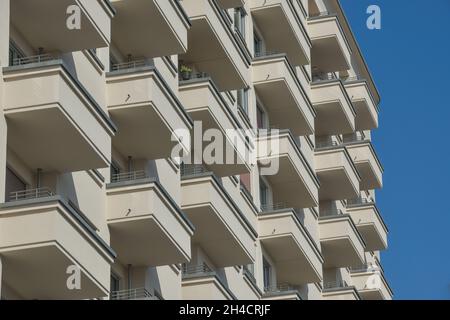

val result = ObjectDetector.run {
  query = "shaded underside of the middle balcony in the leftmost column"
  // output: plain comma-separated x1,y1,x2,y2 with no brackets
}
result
5,104,109,173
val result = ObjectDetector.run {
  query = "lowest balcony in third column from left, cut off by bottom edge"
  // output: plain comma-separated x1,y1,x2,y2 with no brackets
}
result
181,264,236,300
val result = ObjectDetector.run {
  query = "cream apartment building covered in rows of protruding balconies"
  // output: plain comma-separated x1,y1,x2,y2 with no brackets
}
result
0,0,392,300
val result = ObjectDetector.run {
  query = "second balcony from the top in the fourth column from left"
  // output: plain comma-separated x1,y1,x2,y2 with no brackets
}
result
252,54,315,136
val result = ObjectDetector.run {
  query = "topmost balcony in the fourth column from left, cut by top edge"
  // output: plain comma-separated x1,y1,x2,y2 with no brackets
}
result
250,0,312,66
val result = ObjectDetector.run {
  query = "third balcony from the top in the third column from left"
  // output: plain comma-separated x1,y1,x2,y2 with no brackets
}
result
181,167,257,268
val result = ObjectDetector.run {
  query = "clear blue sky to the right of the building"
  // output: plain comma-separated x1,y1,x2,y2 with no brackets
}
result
341,0,450,299
